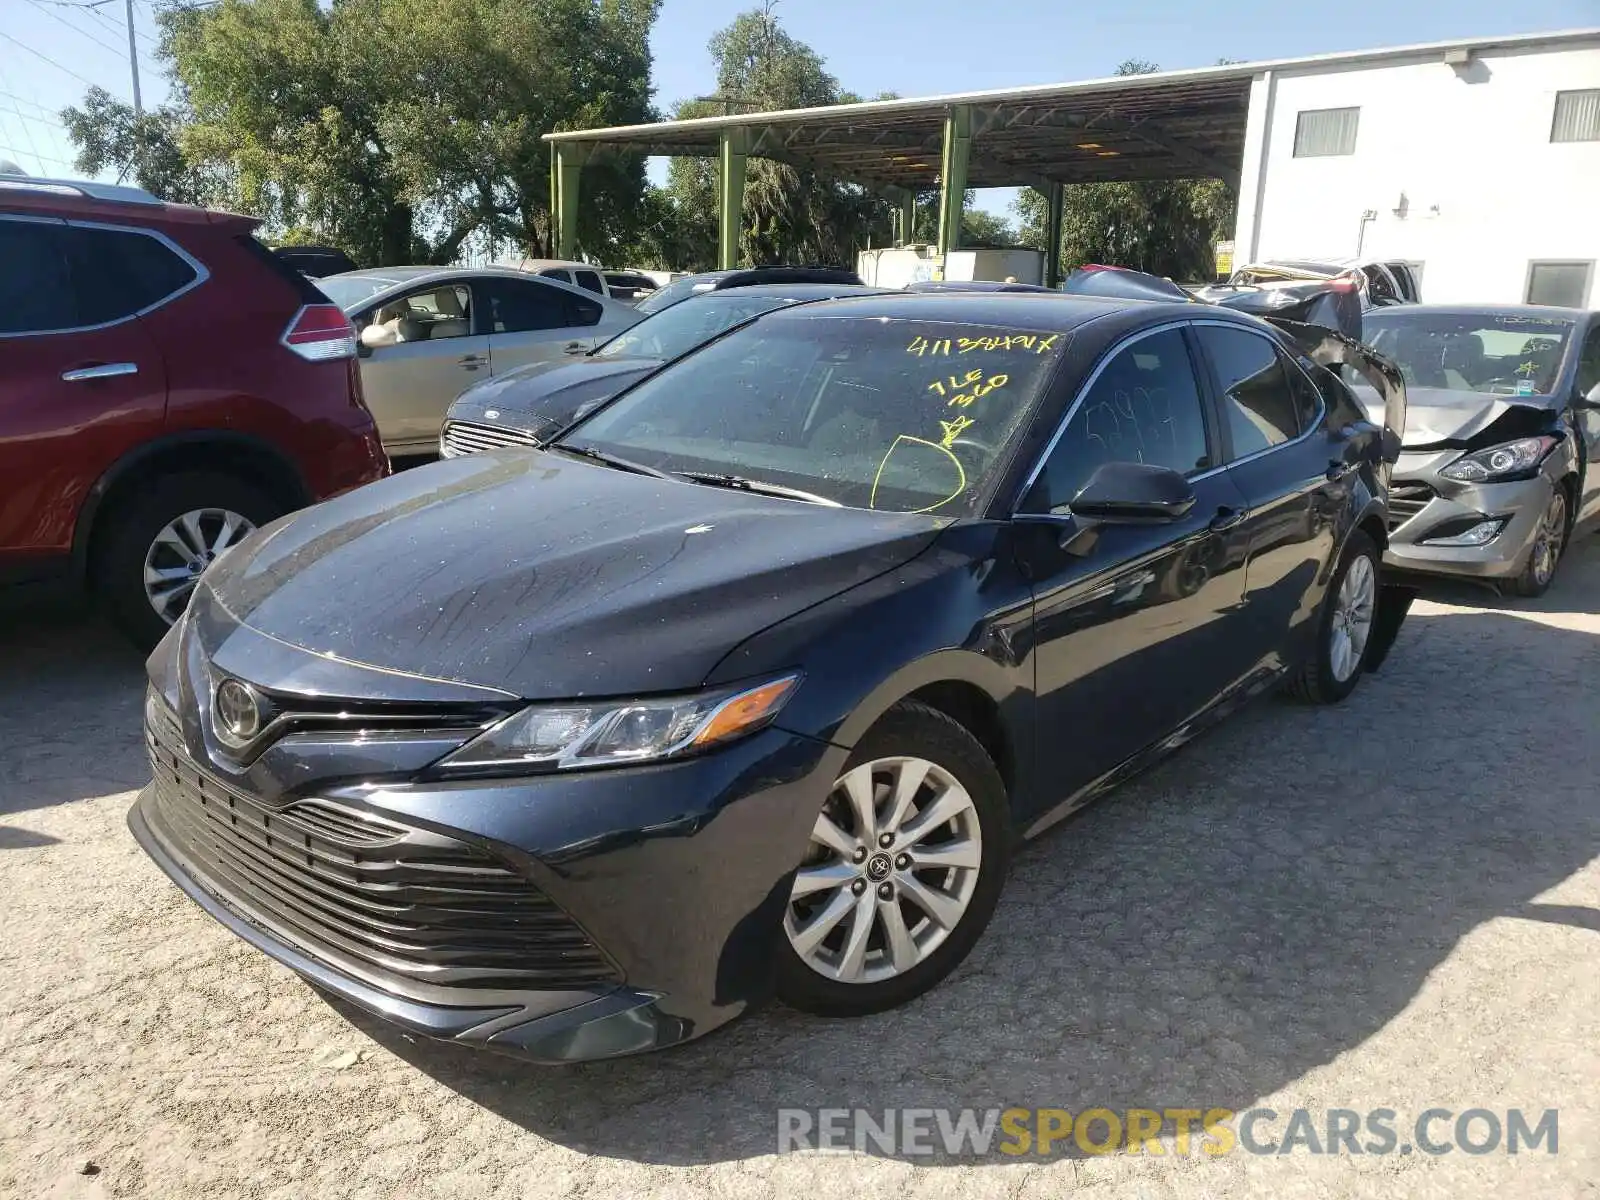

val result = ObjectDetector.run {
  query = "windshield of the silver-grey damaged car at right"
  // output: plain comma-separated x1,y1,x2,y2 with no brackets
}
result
1365,309,1573,395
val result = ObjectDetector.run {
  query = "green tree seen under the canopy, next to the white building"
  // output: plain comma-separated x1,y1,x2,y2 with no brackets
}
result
1014,59,1234,280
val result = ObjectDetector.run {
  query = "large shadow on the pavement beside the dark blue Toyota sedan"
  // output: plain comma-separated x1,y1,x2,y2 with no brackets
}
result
331,550,1600,1165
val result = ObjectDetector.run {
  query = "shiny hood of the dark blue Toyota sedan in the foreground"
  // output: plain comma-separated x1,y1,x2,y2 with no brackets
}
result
195,450,947,699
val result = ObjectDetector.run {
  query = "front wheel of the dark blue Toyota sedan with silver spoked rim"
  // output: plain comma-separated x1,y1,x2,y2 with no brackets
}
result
776,701,1011,1016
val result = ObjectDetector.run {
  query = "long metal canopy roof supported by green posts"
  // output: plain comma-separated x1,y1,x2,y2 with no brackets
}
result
546,29,1600,187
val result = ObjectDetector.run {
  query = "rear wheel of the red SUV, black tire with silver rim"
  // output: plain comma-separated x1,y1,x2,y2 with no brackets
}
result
90,472,283,653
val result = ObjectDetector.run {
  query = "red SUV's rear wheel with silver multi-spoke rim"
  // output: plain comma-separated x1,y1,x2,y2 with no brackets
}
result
90,474,283,650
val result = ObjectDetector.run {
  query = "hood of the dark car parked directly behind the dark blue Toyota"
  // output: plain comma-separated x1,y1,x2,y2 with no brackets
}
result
445,355,661,442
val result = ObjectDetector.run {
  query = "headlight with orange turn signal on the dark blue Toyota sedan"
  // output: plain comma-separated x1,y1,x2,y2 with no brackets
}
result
438,675,800,770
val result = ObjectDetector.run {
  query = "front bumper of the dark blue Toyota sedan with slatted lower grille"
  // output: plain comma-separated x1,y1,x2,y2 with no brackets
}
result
128,681,845,1062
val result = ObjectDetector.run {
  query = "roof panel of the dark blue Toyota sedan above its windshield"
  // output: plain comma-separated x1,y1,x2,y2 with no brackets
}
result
768,291,1211,331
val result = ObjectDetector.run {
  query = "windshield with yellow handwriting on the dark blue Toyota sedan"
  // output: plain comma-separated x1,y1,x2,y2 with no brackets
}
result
562,307,1067,517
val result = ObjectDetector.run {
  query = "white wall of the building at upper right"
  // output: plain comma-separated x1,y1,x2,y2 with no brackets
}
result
1235,37,1600,307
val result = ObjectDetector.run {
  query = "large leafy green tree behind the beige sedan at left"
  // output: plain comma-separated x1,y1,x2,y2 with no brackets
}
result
69,0,659,264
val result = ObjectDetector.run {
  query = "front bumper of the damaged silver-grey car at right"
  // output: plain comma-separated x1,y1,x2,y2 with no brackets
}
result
1384,467,1555,579
